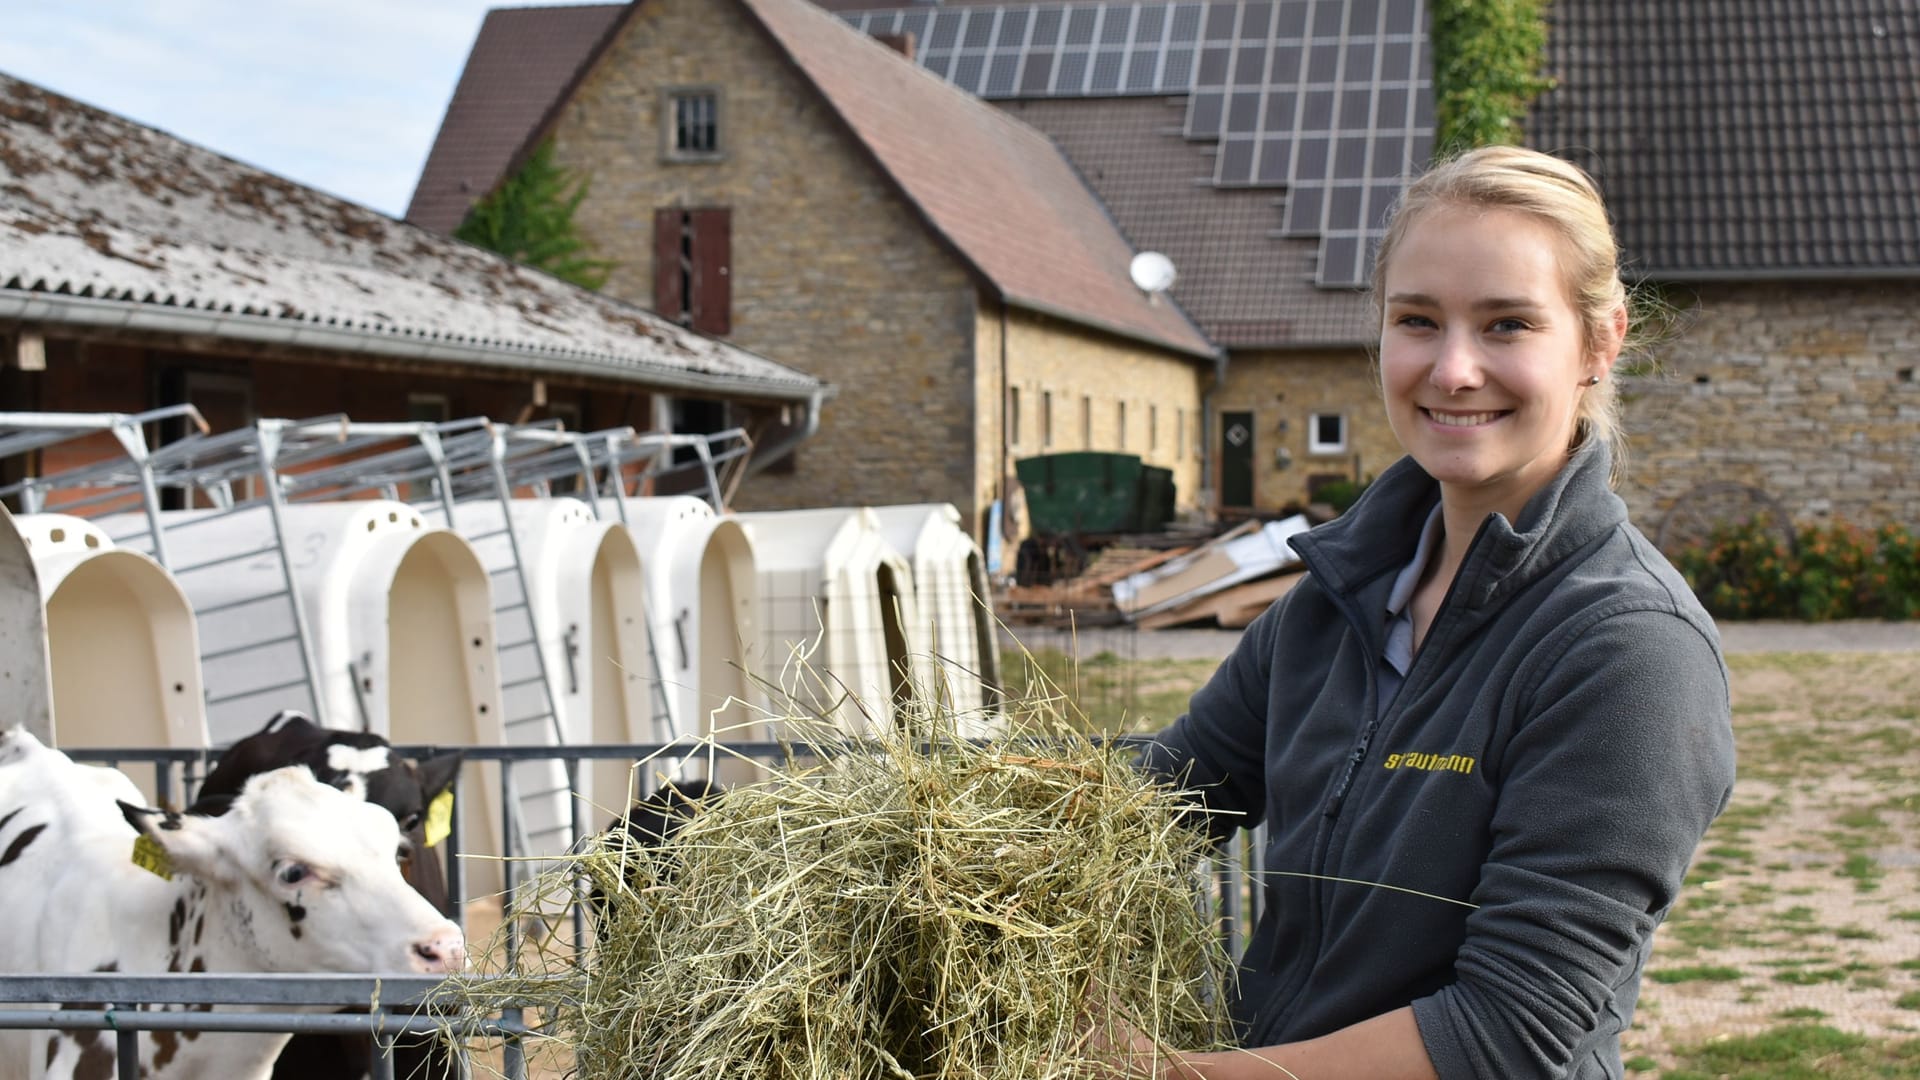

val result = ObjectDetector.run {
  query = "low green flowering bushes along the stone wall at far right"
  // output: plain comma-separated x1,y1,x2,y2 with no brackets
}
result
1674,515,1920,623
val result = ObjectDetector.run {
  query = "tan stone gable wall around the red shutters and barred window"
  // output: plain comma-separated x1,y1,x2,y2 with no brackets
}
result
555,0,981,517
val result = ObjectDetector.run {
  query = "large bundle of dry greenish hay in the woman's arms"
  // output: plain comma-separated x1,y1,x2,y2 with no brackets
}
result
445,714,1231,1080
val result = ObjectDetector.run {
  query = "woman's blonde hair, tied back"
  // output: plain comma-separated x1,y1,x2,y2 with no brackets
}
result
1373,146,1626,482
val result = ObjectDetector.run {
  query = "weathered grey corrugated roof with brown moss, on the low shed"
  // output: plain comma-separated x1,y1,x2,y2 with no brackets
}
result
0,75,824,400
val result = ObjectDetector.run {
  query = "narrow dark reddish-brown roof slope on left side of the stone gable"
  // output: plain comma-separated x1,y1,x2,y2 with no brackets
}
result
407,4,626,233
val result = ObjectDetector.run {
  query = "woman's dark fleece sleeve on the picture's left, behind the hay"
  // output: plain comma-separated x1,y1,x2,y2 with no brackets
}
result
1140,590,1298,840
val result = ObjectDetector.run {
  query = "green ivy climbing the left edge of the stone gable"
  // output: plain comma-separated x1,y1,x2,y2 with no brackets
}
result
453,140,618,288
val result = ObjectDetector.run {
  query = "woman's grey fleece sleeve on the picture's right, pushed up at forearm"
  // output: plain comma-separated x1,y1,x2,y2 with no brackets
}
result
1413,611,1734,1080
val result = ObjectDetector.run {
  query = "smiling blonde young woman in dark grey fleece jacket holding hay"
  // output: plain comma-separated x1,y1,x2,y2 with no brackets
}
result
1129,148,1734,1080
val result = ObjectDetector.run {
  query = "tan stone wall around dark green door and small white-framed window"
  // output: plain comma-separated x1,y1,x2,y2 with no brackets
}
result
1208,350,1402,511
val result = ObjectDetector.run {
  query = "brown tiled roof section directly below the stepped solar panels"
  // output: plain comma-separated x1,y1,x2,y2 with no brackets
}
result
996,98,1377,348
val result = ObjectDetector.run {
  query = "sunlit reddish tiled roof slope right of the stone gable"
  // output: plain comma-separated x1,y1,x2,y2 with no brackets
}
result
741,0,1215,356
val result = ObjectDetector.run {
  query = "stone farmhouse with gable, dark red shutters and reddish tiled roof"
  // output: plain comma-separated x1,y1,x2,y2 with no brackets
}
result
407,0,1219,536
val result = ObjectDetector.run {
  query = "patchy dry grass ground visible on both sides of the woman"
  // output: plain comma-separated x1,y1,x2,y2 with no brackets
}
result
1006,636,1920,1080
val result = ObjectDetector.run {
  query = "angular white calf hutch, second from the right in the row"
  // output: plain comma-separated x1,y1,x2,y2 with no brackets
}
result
739,507,927,732
